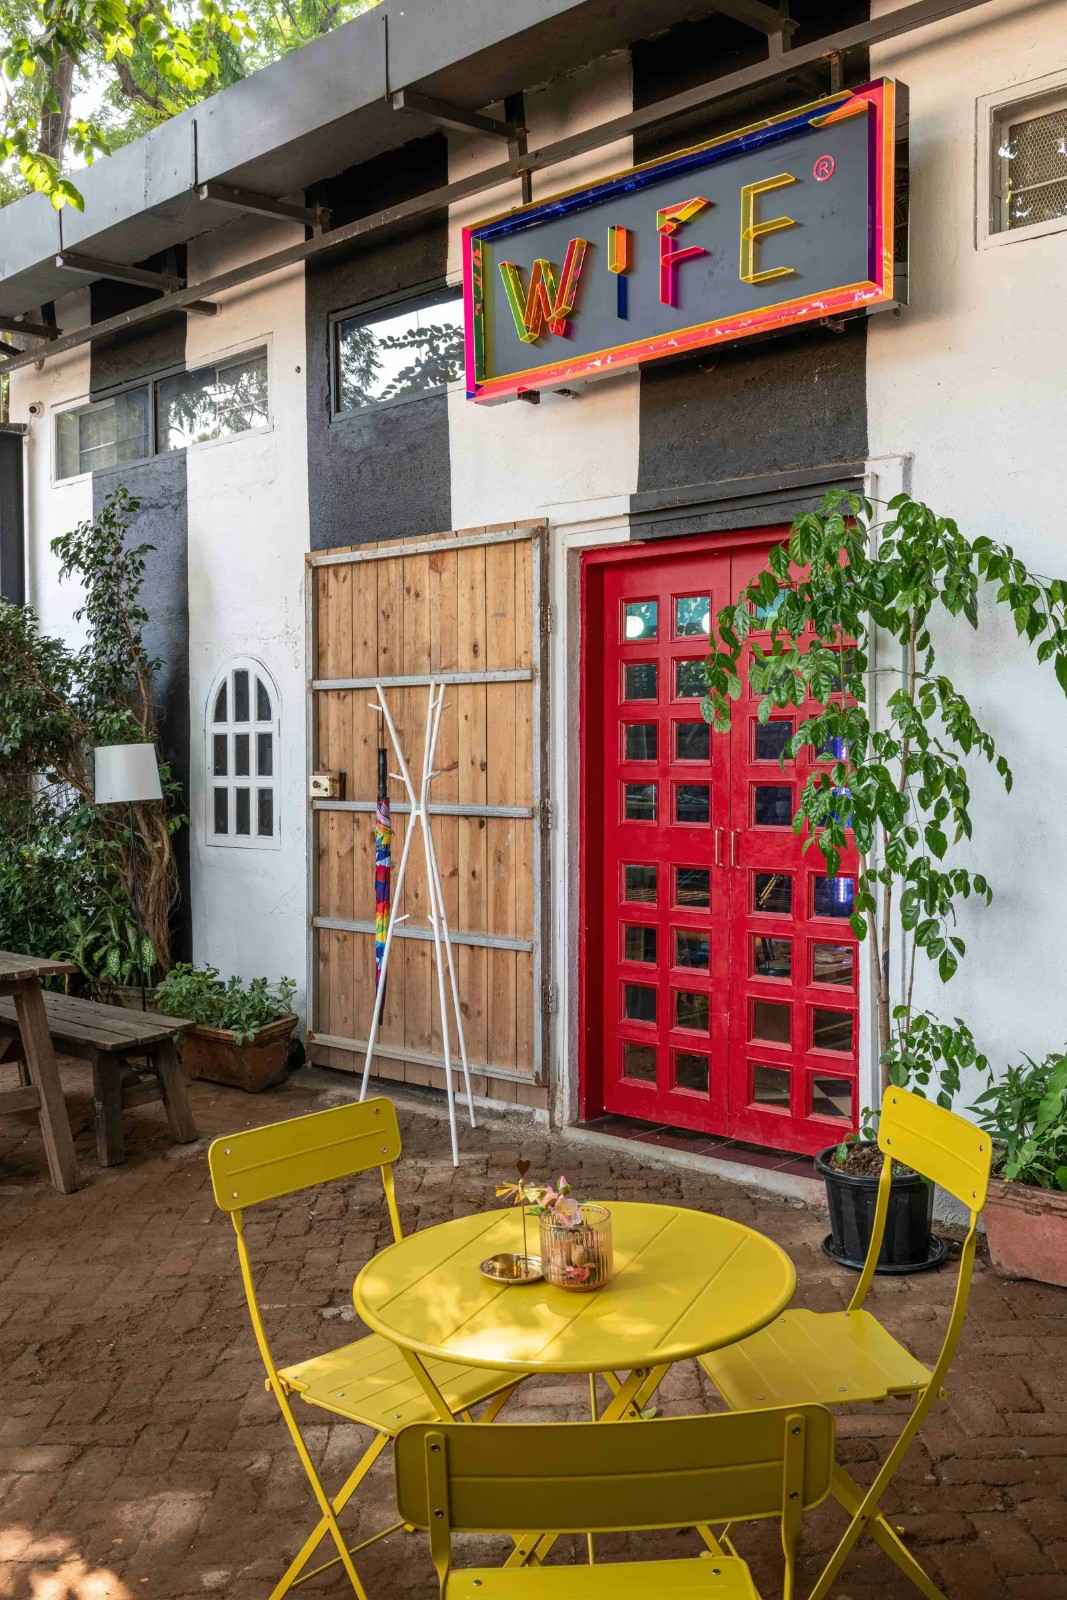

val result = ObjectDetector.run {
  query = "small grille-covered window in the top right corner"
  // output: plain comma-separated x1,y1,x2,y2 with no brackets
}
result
979,80,1067,242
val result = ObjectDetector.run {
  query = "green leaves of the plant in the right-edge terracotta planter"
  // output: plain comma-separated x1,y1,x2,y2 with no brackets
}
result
971,1051,1067,1190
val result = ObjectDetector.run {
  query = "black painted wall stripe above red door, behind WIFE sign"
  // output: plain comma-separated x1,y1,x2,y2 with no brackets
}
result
633,0,869,494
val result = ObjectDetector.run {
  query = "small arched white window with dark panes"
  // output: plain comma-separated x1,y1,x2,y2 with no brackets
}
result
205,658,282,850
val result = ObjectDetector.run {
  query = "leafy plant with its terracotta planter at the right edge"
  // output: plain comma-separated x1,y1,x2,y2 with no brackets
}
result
971,1051,1067,1288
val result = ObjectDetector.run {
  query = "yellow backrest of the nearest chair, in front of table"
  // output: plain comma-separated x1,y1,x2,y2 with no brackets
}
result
397,1405,833,1533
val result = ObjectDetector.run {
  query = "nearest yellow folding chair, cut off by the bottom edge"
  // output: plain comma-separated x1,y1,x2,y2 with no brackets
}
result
397,1405,833,1600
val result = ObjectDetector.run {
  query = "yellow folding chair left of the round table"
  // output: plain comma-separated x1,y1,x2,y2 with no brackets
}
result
208,1099,517,1600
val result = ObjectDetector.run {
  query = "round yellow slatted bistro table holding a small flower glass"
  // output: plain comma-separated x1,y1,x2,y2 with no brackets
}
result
354,1200,797,1565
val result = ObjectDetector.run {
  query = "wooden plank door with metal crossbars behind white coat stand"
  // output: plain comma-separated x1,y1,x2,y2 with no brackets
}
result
309,523,547,1104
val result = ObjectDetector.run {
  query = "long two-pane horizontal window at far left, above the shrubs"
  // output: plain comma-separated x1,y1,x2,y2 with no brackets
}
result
56,350,270,478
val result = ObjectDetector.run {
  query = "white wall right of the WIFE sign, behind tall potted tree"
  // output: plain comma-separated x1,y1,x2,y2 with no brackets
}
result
867,0,1067,1099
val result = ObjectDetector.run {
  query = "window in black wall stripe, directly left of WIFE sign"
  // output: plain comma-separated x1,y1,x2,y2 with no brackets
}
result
333,290,464,411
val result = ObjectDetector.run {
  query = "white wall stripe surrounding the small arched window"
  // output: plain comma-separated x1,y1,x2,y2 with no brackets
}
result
186,222,309,1008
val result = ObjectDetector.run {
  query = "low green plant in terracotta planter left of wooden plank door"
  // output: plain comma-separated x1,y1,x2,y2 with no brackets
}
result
155,962,298,1094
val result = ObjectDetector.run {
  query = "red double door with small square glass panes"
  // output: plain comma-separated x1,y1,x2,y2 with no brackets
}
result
579,528,859,1154
